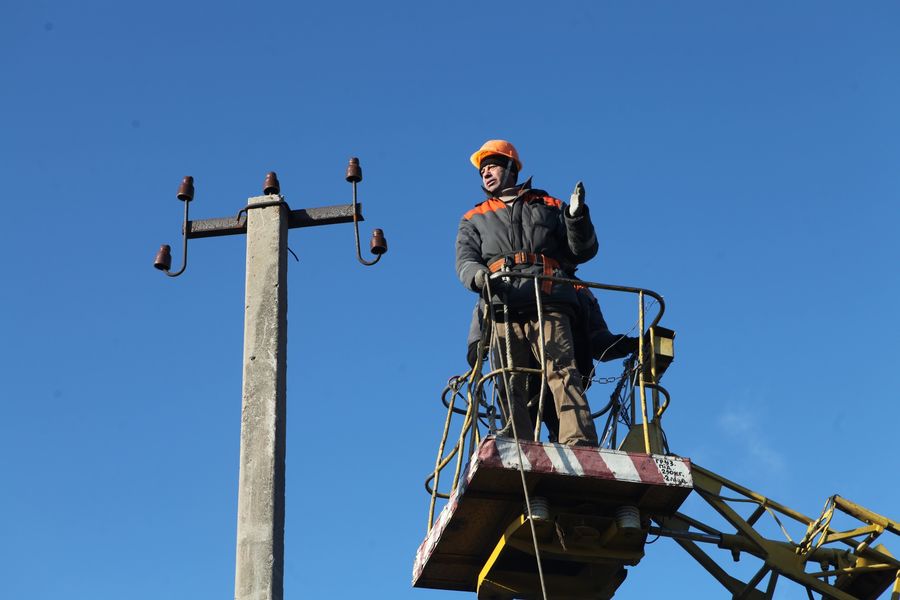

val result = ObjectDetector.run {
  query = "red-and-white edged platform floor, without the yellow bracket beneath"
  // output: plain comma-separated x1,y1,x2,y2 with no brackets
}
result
412,437,693,591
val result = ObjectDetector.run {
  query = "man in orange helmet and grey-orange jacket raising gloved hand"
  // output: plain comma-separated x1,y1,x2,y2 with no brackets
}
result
456,140,597,445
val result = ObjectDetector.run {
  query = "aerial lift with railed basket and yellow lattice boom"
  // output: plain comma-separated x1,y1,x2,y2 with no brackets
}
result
412,273,900,600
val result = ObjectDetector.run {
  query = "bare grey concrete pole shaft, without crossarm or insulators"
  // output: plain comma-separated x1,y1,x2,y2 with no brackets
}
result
234,196,288,600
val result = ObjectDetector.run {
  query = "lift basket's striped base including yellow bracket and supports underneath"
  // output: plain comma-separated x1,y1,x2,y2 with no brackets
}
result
413,436,692,598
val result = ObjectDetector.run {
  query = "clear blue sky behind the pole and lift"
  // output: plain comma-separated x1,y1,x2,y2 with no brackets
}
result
0,0,900,600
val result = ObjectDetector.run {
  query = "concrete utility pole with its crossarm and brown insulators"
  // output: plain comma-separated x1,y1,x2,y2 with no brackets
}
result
154,159,387,600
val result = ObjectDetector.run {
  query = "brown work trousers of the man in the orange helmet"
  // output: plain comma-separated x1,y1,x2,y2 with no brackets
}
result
494,311,597,445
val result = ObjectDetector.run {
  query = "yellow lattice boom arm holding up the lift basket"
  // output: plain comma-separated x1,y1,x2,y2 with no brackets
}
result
651,465,900,600
